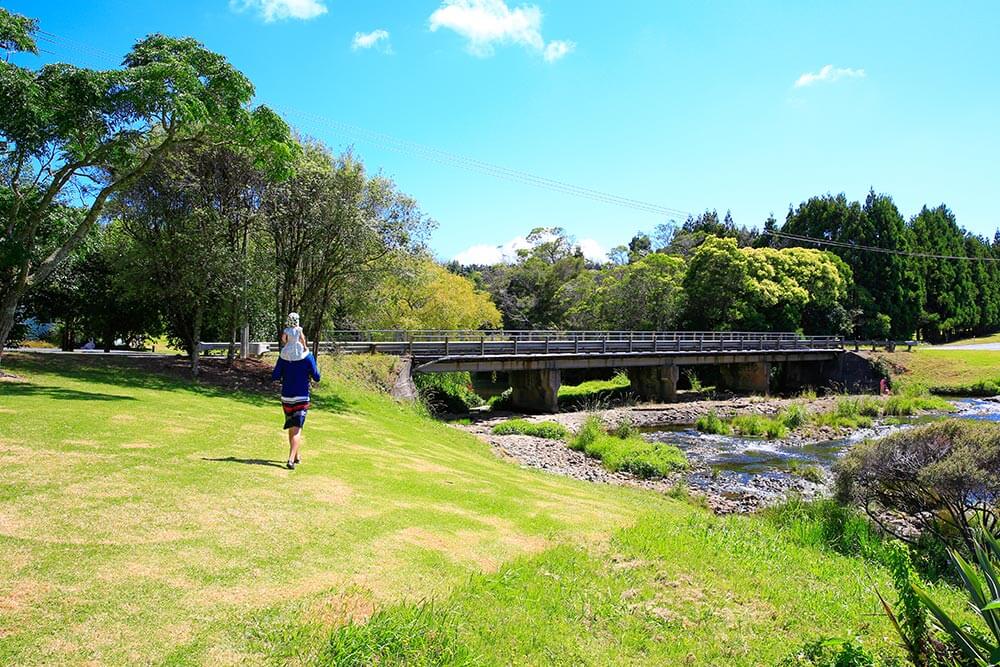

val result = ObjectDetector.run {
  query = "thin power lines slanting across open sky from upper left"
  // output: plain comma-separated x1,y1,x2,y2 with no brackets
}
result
33,31,691,218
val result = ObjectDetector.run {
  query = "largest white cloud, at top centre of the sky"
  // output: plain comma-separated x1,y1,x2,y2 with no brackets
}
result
430,0,575,62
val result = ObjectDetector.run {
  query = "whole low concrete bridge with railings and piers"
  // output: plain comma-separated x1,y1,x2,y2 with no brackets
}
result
320,331,845,412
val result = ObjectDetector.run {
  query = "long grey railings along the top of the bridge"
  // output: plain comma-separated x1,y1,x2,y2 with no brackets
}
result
306,330,843,357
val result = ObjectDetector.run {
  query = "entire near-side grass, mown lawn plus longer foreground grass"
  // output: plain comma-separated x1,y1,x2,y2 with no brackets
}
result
0,355,959,665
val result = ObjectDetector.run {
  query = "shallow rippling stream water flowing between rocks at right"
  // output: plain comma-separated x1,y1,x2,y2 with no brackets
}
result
643,398,1000,507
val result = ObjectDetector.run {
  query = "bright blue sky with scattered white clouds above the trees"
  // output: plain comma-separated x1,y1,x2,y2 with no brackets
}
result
9,0,1000,259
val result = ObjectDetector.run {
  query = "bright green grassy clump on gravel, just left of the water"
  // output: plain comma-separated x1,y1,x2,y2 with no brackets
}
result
570,416,687,479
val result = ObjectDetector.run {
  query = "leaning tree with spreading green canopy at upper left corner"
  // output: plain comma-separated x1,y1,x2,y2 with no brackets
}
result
0,9,290,366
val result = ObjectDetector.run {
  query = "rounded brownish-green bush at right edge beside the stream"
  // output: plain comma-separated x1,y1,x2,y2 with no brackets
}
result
836,420,1000,553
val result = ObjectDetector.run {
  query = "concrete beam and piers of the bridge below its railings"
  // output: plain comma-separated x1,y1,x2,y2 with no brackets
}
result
414,350,841,412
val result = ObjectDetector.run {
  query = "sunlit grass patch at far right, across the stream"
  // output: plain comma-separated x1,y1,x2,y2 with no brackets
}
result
879,348,1000,394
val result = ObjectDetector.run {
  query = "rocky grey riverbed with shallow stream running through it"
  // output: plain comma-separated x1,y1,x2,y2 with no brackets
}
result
460,397,1000,514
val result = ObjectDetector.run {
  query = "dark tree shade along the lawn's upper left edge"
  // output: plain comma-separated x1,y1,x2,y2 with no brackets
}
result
4,353,351,413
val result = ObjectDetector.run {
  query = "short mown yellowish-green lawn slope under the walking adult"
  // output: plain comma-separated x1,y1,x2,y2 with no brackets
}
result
0,355,639,664
